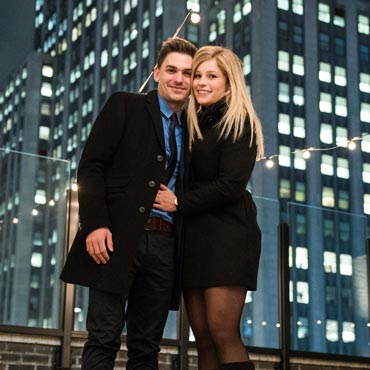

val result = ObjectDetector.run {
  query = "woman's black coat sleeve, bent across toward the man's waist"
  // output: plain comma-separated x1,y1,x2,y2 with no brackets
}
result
177,126,256,215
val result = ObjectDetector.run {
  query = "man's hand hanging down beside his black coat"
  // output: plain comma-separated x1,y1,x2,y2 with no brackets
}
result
86,227,113,265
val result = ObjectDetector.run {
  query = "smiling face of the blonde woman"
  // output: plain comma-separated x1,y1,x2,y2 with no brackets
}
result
193,59,226,107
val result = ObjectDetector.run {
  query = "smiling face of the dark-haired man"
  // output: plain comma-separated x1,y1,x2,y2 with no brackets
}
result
154,52,193,111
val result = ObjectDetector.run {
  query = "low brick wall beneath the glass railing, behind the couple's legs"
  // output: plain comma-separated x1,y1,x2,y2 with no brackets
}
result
0,332,370,370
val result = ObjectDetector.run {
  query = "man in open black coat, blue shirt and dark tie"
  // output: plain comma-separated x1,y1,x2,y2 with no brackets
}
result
61,38,196,370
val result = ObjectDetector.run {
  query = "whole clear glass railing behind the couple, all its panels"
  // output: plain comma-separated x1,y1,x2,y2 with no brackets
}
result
0,155,370,357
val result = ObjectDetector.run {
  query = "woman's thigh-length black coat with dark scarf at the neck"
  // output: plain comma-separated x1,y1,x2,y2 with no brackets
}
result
178,101,261,290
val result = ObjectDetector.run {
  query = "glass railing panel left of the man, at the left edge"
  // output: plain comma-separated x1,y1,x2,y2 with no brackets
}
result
0,150,69,328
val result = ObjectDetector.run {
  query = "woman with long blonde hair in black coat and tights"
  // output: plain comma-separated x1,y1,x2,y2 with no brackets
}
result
155,46,263,370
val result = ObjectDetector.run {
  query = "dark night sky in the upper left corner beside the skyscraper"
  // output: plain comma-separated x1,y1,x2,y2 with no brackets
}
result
0,0,35,85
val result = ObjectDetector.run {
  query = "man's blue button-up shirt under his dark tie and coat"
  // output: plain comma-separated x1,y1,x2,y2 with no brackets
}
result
150,93,182,223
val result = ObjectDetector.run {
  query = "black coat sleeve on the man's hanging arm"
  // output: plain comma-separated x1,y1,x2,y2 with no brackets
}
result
77,93,124,235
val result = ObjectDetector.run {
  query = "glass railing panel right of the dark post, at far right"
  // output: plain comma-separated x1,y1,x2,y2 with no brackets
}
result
288,203,370,357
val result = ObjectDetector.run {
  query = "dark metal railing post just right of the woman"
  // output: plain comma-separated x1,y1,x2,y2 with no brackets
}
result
278,224,290,370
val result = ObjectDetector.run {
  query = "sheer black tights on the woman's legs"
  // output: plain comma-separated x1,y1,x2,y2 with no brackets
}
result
184,286,249,370
